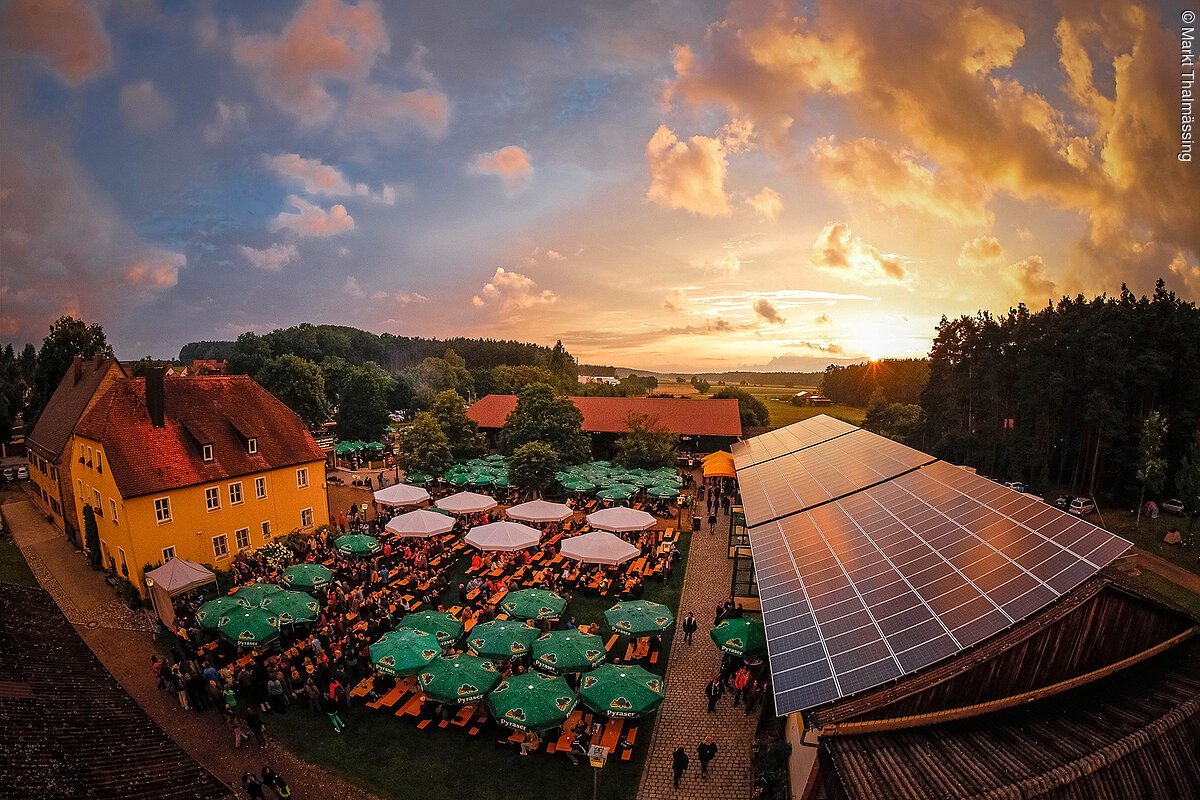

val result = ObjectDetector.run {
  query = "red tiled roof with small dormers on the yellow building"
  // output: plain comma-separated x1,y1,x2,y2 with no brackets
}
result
76,375,325,498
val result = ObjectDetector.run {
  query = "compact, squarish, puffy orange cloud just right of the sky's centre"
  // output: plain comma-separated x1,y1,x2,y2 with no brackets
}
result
646,125,730,217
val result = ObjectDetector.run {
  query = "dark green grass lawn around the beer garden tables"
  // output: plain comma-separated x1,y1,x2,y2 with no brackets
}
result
268,531,698,800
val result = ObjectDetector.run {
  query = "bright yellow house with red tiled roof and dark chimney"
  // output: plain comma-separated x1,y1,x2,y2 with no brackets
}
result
70,368,329,593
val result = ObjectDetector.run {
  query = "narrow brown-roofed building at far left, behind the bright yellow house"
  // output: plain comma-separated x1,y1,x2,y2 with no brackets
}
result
25,356,126,546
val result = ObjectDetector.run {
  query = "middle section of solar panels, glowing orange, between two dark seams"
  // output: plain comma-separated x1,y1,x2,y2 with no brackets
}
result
738,426,934,525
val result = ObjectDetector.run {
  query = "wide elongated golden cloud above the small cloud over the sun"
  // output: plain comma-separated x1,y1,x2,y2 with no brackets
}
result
812,137,991,227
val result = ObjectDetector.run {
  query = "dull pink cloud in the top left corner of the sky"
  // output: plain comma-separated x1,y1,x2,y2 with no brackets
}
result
0,0,113,85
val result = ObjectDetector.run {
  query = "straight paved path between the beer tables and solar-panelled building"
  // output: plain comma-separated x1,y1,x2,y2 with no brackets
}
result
637,503,757,800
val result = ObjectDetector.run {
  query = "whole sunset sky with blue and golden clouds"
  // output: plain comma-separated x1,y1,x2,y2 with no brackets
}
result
0,0,1200,372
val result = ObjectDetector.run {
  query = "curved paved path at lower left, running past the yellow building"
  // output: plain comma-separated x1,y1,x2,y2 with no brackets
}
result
4,495,373,800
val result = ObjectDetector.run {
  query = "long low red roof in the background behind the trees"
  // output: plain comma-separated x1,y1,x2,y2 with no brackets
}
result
467,395,742,437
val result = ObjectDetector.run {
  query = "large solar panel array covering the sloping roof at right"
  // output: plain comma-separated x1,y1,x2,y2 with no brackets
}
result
739,423,1129,714
